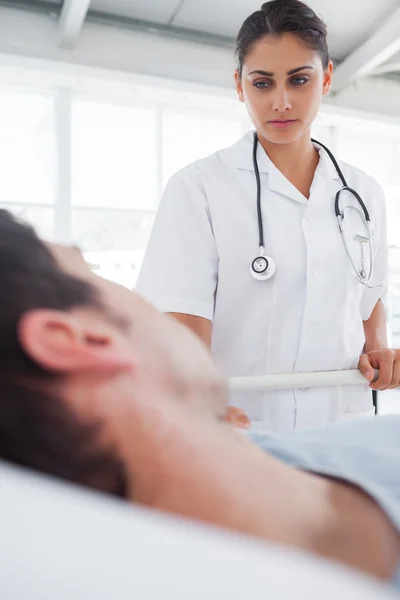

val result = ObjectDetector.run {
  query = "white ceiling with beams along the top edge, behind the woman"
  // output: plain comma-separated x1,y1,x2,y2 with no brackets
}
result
0,0,400,88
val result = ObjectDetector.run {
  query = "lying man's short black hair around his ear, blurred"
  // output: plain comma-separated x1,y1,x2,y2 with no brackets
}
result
0,210,127,496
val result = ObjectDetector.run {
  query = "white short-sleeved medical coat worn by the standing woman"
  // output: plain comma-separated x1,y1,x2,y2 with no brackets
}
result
137,132,387,431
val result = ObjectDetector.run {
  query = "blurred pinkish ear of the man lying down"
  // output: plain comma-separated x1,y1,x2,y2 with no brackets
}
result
18,309,134,373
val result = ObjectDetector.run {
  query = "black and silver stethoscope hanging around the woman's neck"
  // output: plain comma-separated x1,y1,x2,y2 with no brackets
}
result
250,133,380,288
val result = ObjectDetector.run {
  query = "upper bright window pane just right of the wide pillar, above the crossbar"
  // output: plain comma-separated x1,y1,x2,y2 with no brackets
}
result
71,100,158,210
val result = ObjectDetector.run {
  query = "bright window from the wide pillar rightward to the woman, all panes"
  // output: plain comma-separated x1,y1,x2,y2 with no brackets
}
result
71,98,244,288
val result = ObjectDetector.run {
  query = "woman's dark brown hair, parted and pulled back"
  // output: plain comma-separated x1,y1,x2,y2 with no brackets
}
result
235,0,329,75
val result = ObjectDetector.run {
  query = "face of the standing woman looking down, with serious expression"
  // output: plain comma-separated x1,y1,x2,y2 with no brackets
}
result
235,34,333,144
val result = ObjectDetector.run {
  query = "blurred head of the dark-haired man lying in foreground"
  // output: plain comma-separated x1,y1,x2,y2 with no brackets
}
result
0,211,226,495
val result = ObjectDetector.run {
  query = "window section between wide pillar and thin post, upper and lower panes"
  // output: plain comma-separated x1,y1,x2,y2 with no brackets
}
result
71,99,159,288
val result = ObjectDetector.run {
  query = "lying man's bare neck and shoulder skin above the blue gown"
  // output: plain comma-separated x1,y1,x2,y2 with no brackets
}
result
105,392,398,578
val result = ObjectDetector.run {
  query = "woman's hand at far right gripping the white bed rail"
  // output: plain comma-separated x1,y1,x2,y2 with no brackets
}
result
358,348,400,390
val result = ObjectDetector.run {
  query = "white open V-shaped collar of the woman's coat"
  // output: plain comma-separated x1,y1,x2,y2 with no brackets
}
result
229,131,341,204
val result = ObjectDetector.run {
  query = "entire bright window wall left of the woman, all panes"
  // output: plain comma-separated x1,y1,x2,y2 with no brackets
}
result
0,84,248,288
